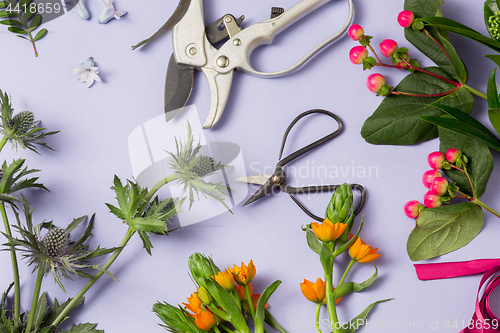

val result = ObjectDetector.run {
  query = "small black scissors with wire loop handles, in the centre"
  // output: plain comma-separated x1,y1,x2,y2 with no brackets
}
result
236,109,365,222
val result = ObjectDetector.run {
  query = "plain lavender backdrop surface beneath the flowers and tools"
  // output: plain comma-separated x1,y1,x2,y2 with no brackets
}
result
0,0,500,333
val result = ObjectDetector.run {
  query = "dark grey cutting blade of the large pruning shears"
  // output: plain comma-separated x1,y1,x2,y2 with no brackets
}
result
165,53,194,121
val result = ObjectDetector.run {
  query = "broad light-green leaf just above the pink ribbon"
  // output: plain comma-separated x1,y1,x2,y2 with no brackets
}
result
406,202,484,261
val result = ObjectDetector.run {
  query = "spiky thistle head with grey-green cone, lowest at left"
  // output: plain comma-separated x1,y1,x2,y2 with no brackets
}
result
4,196,117,291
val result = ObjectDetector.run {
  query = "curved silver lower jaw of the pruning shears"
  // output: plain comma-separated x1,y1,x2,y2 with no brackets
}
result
201,65,234,128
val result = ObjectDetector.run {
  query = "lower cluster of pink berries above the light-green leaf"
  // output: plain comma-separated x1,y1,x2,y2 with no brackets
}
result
404,148,467,219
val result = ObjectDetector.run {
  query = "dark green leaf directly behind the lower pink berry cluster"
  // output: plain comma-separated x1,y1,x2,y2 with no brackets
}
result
439,128,493,199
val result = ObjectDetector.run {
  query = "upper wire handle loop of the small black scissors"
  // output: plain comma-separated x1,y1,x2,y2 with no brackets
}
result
277,109,344,167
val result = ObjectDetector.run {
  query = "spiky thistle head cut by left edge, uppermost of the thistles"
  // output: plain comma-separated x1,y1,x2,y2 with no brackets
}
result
0,90,59,153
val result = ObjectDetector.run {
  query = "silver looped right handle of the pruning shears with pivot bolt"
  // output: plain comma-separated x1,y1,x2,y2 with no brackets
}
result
211,0,353,77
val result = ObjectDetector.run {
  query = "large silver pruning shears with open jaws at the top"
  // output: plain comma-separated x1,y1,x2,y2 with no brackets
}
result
165,0,353,128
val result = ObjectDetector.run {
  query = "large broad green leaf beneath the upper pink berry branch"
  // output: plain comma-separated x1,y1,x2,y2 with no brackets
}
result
361,67,474,145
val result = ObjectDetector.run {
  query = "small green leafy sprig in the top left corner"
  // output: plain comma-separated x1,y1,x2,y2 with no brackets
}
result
0,0,47,57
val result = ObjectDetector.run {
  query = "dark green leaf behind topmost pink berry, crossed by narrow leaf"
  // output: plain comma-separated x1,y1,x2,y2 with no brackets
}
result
404,0,456,75
